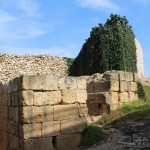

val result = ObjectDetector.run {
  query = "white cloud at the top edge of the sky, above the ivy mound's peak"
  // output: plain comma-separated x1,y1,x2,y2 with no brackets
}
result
77,0,119,11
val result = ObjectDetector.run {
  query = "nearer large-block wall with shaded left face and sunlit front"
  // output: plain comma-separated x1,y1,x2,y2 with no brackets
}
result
0,75,87,150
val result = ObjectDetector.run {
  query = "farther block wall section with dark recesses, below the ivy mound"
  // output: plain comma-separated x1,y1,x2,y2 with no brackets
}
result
87,71,138,115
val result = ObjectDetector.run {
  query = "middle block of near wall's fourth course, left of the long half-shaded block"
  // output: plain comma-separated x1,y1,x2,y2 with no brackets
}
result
42,121,60,137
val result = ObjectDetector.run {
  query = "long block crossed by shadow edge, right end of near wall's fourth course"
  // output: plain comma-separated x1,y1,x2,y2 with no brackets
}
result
61,117,87,134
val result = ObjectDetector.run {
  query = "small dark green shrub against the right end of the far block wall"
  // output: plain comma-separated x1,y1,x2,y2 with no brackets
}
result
137,81,146,100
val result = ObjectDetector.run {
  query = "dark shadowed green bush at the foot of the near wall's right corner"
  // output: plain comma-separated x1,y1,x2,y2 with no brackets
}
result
81,125,110,147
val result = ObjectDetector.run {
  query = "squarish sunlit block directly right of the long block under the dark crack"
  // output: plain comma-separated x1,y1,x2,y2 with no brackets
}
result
62,89,77,104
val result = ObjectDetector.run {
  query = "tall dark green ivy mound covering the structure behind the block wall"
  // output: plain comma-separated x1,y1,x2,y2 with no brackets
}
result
70,15,137,76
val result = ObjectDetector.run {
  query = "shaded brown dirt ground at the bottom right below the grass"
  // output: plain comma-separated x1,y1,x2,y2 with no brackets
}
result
86,119,150,150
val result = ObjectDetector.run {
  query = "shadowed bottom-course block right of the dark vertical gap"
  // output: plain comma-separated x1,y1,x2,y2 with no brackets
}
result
56,134,81,150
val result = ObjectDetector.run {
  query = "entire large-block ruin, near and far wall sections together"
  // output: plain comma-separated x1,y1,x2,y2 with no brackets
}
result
0,71,138,150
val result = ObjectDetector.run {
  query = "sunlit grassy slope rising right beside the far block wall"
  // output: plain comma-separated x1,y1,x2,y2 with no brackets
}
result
97,86,150,125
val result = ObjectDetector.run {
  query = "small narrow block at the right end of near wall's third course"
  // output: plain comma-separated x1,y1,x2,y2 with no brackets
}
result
78,104,88,117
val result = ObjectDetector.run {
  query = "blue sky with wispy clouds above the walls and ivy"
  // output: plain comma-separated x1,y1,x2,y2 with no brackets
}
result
0,0,150,77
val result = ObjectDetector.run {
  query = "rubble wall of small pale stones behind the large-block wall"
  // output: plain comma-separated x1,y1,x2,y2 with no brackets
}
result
0,53,68,82
